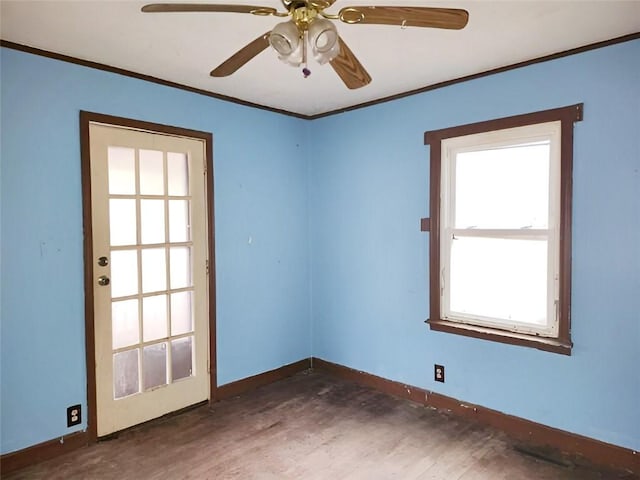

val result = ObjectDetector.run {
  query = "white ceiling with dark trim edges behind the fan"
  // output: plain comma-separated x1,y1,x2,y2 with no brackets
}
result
0,0,640,116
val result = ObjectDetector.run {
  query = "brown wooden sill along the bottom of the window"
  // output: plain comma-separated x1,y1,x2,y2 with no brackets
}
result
425,319,573,355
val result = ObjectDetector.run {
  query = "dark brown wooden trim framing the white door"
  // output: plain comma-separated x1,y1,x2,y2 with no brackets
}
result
80,110,218,443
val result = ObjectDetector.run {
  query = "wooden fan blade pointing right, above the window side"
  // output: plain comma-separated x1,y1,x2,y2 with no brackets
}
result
338,6,469,30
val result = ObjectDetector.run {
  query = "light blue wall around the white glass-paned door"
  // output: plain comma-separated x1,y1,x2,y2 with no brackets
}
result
0,48,311,453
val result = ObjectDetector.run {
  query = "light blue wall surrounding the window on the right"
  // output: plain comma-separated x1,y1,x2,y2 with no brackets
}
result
310,41,640,450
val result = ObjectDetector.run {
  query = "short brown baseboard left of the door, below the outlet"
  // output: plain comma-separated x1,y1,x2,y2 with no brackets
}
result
0,432,89,474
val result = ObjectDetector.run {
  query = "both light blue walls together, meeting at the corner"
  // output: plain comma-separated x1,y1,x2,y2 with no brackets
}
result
0,41,640,453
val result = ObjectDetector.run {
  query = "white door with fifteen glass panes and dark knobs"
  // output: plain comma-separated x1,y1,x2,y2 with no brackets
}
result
89,123,210,436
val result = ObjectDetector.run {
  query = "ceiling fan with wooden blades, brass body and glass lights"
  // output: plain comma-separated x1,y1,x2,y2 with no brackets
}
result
142,0,469,89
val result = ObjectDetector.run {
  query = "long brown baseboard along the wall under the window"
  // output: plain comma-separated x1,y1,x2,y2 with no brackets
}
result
311,357,640,474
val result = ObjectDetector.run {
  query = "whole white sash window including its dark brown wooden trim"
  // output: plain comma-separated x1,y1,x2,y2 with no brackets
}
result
425,104,582,355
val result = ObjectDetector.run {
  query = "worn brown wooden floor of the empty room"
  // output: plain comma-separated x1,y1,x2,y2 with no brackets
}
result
3,372,635,480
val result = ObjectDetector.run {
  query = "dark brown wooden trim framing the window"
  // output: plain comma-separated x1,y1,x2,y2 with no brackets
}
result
424,103,583,355
